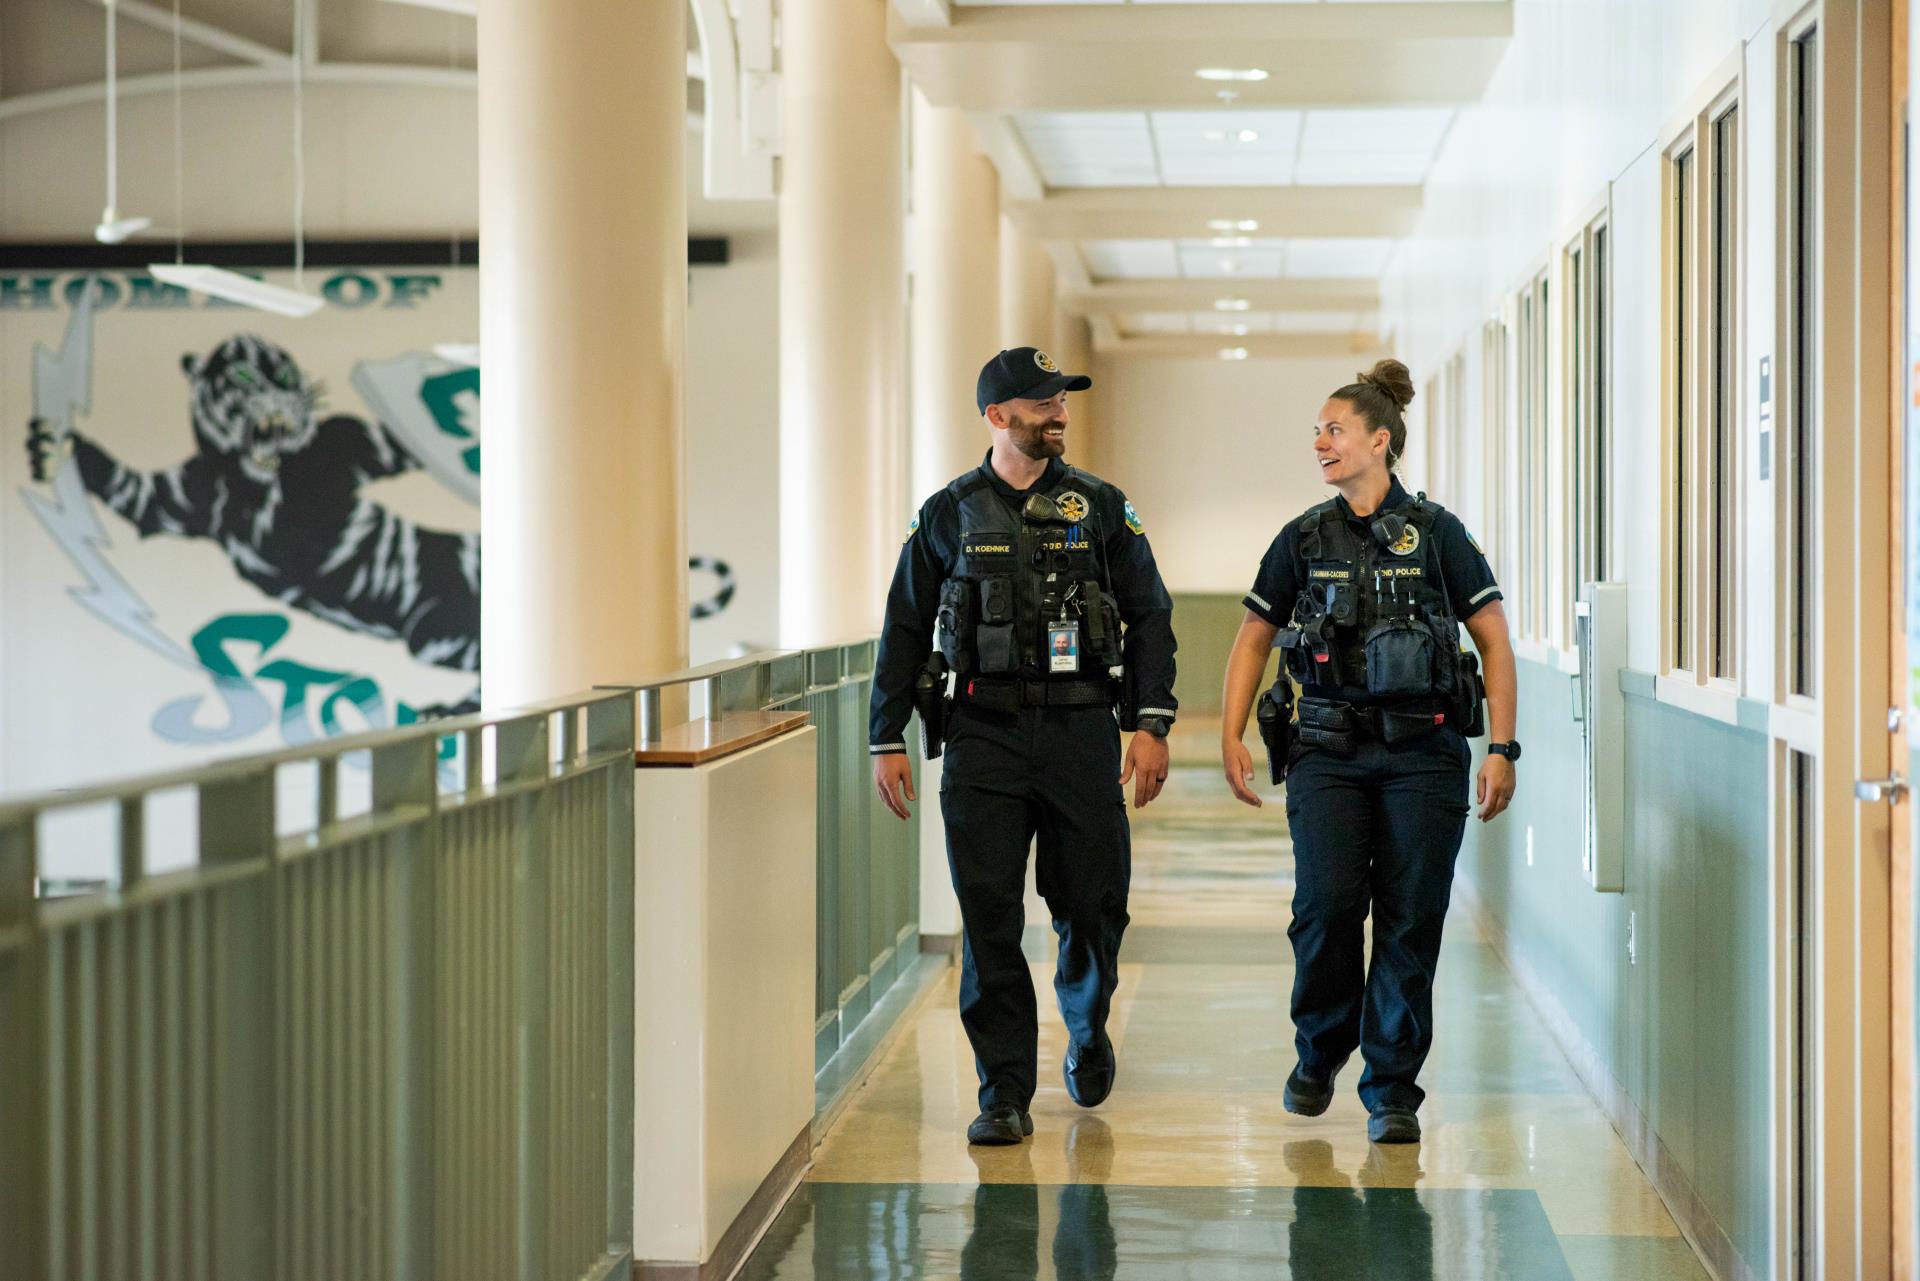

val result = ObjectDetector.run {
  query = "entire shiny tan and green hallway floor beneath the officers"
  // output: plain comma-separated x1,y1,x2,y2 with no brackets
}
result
741,764,1707,1281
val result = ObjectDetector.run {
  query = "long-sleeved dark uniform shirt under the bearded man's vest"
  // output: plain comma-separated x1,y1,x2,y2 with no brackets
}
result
868,451,1179,755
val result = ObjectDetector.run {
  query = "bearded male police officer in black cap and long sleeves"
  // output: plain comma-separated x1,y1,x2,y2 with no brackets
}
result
868,348,1175,1143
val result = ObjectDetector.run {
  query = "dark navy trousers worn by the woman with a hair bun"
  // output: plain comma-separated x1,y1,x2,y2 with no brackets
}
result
1286,728,1471,1110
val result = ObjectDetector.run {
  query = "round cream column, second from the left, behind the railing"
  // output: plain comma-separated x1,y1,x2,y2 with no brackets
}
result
780,0,906,645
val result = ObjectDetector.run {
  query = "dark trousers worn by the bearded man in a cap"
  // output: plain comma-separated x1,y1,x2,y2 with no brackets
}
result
941,701,1133,1110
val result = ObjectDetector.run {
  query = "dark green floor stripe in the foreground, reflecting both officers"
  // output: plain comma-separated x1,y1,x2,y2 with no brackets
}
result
739,1183,1578,1281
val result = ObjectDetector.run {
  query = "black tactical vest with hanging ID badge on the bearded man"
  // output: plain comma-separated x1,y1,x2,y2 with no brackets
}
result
939,467,1119,680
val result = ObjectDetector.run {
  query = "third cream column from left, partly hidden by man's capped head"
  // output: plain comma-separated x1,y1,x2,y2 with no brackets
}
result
908,92,1000,507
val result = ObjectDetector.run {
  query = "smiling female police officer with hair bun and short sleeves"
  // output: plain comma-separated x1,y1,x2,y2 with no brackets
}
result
1221,361,1521,1143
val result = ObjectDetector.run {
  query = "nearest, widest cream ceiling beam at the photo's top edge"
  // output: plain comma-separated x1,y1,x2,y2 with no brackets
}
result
887,0,1513,111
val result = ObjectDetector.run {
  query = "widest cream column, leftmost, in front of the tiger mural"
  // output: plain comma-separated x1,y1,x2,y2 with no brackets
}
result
478,0,687,707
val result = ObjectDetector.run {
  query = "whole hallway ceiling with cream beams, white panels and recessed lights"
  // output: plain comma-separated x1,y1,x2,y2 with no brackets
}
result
889,0,1513,359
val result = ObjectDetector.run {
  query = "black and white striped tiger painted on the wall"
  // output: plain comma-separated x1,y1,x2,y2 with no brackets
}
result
27,334,480,672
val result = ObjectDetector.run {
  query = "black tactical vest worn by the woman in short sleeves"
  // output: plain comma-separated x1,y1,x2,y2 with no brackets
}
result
1283,495,1459,703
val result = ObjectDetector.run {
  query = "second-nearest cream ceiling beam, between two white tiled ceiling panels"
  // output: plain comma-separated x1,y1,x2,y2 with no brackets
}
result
1004,188,1421,240
